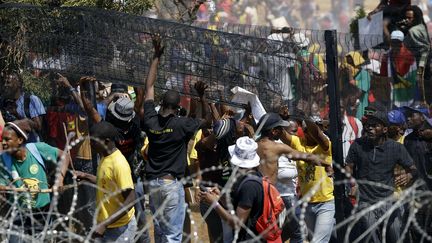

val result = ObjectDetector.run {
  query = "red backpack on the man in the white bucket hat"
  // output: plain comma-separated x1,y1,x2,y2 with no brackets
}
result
237,175,285,243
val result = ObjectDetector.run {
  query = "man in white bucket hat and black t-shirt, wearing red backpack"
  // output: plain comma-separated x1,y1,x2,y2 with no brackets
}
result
200,137,264,241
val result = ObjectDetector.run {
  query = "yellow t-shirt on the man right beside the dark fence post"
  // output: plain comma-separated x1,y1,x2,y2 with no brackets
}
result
291,136,334,203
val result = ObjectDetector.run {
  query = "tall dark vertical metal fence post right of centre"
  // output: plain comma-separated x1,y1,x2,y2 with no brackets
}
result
324,30,345,242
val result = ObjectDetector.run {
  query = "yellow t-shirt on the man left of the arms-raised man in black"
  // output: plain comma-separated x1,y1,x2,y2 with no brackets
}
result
96,150,135,228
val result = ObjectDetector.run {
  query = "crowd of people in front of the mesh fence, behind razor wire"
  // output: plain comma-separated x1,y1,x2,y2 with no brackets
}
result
0,31,432,242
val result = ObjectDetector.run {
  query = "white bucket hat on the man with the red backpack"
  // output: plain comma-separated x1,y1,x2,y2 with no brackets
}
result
228,137,260,169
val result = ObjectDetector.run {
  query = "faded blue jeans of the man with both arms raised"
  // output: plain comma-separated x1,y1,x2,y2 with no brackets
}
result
149,179,186,243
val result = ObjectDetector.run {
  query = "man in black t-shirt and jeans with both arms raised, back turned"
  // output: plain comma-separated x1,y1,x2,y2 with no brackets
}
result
141,37,211,242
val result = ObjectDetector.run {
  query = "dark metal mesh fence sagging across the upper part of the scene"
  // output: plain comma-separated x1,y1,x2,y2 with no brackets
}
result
0,2,432,242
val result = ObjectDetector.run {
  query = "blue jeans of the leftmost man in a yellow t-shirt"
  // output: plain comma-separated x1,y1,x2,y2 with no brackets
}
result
95,217,137,243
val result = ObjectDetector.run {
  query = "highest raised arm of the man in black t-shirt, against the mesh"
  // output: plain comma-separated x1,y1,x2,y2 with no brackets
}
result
144,35,165,101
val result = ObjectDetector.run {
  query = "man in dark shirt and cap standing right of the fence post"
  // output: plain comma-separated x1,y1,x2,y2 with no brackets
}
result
346,111,416,243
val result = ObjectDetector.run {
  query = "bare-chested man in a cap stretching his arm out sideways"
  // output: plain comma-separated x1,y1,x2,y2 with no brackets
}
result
253,113,325,184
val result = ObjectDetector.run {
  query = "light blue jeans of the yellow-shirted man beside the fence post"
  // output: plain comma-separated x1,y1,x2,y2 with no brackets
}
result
305,200,336,243
